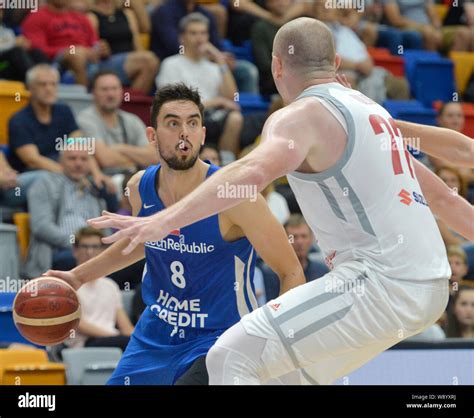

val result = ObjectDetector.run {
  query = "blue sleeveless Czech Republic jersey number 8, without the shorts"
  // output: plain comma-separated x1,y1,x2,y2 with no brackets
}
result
138,165,257,345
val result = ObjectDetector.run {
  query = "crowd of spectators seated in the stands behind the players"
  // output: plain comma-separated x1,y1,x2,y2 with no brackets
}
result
0,0,474,346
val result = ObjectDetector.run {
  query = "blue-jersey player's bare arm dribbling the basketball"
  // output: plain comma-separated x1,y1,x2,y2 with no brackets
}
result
43,171,145,290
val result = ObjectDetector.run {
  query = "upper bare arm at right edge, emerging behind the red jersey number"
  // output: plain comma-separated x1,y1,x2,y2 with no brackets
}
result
396,120,474,168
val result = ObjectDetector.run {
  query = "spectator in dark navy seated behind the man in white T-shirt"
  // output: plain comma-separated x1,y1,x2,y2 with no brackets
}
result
151,0,258,93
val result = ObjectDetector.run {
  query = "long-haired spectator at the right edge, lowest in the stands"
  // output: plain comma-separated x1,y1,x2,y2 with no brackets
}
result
446,286,474,338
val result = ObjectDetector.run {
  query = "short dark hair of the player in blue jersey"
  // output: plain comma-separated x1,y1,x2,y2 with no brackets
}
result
151,83,204,129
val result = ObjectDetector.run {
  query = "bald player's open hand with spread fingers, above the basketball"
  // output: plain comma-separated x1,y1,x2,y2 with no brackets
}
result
87,210,169,255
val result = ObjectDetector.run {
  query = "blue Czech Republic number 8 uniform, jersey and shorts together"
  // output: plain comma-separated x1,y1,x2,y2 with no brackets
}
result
108,165,257,385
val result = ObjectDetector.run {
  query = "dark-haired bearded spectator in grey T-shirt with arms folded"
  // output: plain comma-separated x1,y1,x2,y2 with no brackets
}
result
77,70,158,175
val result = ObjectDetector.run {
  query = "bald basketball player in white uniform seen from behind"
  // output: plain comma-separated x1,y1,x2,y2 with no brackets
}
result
90,18,474,384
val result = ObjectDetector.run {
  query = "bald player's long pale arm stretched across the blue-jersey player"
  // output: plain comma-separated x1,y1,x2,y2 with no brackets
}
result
89,108,314,254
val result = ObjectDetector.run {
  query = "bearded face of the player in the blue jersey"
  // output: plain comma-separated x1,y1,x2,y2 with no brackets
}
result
156,101,206,170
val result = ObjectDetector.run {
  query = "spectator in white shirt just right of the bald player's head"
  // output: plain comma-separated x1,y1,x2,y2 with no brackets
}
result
313,0,410,103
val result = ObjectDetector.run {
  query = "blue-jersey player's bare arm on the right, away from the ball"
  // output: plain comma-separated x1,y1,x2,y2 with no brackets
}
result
223,194,306,293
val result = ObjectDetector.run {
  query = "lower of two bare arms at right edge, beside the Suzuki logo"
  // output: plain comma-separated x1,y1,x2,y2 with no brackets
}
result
412,158,474,241
